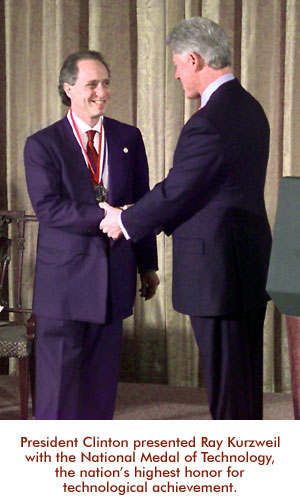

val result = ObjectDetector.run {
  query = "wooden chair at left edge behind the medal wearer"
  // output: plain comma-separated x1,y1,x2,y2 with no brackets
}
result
0,210,37,419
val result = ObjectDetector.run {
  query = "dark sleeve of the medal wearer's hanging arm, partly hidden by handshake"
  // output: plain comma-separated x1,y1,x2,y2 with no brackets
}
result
133,131,158,272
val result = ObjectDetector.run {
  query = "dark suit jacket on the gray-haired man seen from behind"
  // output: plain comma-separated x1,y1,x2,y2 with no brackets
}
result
122,80,271,316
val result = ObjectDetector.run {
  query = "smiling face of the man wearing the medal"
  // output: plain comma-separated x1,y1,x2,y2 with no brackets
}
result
64,59,111,127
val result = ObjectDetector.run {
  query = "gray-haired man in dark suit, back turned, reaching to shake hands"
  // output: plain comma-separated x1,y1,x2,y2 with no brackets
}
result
100,18,271,419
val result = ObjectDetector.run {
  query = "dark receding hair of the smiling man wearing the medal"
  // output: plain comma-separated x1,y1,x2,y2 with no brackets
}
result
58,50,110,106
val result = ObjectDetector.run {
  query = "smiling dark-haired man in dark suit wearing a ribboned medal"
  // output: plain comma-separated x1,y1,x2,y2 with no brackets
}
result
24,51,159,419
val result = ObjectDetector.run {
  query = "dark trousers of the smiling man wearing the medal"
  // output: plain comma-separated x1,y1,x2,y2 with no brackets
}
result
35,316,122,420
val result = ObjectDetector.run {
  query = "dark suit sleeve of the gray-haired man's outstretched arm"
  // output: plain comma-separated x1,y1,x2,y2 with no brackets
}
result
122,119,224,241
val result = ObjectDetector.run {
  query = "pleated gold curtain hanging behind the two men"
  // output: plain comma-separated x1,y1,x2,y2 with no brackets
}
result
0,0,300,391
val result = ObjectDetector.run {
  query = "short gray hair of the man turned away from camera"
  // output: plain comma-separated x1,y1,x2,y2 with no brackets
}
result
167,17,231,69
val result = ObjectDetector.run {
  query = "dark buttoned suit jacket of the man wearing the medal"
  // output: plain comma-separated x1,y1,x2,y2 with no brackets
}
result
24,117,157,323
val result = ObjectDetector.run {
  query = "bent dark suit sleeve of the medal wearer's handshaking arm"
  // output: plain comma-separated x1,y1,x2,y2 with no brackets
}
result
24,137,104,234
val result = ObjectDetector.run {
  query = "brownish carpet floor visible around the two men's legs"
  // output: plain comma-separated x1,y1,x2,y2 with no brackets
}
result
0,375,294,420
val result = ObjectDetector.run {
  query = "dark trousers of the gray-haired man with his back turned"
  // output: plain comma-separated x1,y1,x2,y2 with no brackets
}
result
191,307,266,420
